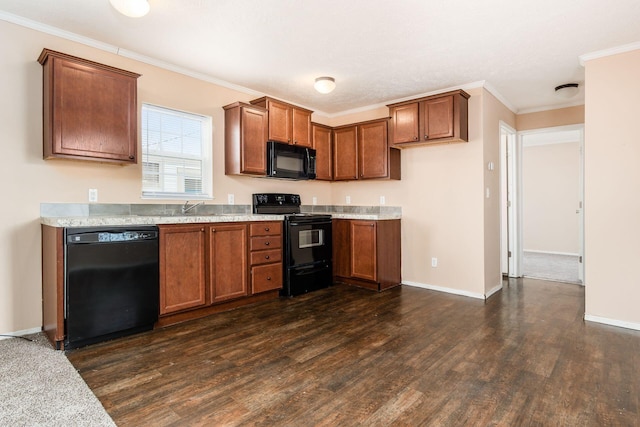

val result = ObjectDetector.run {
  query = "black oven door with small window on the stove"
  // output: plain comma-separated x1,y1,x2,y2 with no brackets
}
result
285,218,332,267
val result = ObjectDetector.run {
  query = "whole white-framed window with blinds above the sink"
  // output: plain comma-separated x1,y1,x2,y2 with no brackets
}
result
142,104,213,199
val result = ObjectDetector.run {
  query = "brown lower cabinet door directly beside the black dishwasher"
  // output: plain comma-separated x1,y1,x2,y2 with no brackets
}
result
159,225,206,315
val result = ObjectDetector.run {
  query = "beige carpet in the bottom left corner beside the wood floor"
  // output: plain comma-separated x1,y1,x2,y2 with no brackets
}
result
0,334,115,426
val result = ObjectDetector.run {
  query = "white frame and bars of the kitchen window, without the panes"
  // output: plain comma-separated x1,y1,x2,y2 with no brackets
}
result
140,102,214,200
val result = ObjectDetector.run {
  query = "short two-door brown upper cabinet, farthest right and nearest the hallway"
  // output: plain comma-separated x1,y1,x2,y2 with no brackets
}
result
388,90,469,147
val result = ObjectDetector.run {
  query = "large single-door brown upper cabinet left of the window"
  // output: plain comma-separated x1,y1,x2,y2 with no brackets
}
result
38,49,140,163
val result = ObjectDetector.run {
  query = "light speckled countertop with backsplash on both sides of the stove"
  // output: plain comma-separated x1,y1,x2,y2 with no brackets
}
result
40,204,402,227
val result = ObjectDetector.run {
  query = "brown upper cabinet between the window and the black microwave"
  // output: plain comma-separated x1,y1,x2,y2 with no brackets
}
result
223,102,268,175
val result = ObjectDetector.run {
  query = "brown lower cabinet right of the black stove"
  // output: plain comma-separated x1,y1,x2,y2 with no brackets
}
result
332,219,401,291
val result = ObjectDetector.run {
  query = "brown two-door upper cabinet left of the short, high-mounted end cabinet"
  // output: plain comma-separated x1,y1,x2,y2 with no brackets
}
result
333,118,400,181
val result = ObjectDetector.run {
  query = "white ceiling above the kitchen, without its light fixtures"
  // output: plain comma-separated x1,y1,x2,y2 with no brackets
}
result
0,0,640,116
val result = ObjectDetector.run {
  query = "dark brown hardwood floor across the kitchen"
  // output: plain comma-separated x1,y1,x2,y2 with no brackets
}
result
67,279,640,426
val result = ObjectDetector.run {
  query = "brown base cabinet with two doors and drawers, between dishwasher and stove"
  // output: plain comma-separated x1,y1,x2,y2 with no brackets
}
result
158,221,282,326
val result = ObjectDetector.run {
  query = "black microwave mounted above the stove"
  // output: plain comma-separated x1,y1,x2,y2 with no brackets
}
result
267,141,316,179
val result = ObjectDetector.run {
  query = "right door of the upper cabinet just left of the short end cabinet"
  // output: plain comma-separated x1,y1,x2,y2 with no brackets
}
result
358,120,389,179
